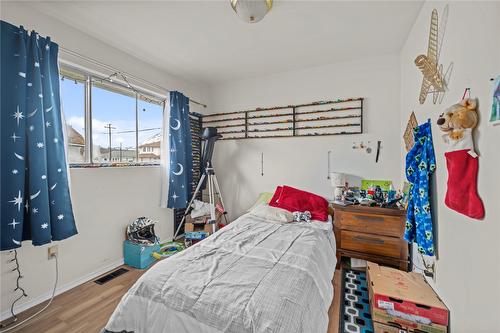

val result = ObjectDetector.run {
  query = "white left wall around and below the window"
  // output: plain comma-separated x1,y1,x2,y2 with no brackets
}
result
0,2,206,318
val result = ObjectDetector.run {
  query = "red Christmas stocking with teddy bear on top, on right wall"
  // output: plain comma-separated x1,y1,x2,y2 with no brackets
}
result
437,98,484,219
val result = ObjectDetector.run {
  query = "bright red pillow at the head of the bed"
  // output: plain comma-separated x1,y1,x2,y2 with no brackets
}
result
269,185,328,221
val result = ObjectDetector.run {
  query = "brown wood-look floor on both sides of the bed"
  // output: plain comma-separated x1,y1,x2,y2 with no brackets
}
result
1,266,340,333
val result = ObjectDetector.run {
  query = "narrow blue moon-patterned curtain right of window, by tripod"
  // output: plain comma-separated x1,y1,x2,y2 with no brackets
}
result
167,91,193,208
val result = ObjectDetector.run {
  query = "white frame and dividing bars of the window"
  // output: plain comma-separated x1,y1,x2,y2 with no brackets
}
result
59,64,166,168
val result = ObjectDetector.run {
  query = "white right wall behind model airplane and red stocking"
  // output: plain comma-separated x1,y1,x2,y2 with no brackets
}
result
400,2,500,333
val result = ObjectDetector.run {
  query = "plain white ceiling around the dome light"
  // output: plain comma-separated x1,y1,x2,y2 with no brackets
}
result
23,0,423,84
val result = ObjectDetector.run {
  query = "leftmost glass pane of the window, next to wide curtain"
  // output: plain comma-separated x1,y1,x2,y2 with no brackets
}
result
61,76,85,163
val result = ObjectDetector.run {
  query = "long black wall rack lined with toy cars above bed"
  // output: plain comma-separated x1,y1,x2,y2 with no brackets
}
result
202,98,363,140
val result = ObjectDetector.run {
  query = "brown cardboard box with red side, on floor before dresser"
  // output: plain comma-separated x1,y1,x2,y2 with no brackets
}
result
367,262,449,333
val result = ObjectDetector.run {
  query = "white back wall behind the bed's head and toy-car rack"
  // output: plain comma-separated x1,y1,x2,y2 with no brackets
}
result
211,55,401,218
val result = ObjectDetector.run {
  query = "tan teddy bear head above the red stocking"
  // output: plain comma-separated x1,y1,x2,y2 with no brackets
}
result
437,98,478,141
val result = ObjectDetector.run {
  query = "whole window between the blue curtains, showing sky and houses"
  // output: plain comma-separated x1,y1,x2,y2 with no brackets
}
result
61,68,163,164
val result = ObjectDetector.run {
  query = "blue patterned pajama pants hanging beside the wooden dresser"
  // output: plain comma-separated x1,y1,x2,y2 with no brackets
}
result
404,121,436,256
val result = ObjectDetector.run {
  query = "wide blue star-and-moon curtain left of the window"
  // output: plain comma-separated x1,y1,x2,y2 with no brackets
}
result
0,21,77,251
